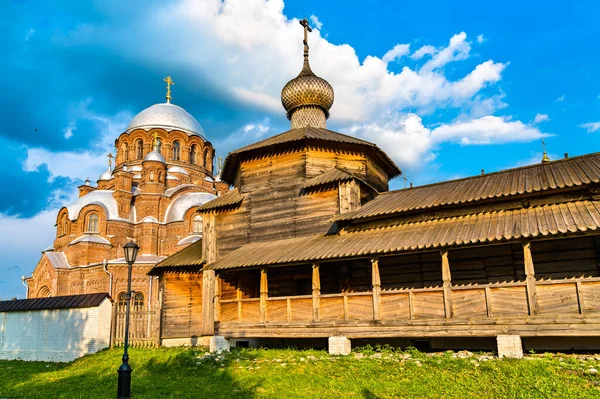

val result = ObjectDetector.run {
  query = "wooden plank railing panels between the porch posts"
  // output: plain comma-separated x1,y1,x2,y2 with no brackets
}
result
218,277,600,324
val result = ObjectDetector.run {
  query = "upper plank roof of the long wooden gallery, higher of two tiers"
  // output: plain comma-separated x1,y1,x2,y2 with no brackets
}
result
336,153,600,220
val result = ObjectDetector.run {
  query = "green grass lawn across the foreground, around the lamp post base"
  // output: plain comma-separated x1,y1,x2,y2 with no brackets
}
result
0,347,600,399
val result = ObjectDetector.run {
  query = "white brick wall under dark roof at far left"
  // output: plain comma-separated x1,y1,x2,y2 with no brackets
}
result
0,298,112,362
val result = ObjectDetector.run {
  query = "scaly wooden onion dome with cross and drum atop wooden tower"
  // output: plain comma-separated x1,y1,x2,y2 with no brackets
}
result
281,19,334,129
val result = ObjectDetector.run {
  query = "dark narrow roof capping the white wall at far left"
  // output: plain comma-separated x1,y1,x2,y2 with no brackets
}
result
0,292,110,312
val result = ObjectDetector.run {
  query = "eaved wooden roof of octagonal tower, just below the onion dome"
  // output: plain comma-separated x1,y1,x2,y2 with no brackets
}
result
221,126,402,184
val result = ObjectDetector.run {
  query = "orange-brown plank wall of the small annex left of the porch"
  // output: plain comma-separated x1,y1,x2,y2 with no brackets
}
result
161,272,202,338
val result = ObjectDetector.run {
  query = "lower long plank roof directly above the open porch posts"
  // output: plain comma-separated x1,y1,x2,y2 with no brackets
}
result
205,201,600,270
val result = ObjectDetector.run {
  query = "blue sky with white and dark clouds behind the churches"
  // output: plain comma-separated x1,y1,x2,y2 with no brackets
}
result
0,0,600,299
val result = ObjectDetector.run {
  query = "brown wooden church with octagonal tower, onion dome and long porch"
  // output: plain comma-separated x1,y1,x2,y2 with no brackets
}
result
149,19,600,353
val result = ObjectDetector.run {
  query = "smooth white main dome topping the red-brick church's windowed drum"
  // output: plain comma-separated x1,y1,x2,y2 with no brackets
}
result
127,103,206,139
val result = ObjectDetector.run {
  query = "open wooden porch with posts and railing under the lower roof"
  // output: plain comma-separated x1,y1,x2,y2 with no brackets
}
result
214,237,600,338
